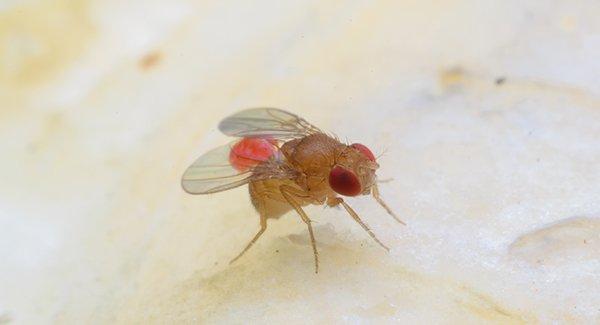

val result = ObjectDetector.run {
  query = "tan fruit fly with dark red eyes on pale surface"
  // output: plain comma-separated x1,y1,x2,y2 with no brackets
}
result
181,108,404,273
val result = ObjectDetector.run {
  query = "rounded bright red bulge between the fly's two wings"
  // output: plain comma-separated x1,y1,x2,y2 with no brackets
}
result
229,138,278,172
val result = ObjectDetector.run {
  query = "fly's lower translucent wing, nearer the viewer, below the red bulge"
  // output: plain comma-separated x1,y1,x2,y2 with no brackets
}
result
181,142,295,194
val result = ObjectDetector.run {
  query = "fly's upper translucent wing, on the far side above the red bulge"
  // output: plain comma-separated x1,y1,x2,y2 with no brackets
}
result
219,108,321,140
